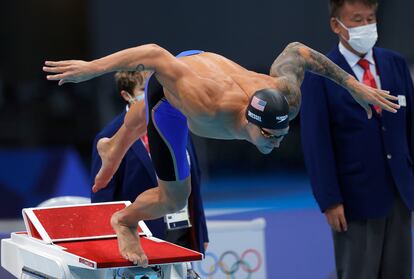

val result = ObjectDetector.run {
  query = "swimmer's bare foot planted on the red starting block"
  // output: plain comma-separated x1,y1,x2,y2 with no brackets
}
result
111,211,148,267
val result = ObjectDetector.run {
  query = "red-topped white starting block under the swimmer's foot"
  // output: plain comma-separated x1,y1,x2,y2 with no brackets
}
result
1,201,203,279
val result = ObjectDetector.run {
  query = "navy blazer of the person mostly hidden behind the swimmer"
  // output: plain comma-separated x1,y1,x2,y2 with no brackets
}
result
91,112,208,253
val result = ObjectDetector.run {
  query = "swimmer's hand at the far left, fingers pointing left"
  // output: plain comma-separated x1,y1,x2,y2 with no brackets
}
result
43,60,100,85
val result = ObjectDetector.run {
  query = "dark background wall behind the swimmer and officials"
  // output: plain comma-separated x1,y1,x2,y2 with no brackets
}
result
0,0,414,179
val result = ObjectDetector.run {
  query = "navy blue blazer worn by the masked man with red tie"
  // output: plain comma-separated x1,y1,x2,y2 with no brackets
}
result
300,47,414,220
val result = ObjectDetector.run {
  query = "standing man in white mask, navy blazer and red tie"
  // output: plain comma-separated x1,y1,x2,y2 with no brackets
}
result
301,0,414,279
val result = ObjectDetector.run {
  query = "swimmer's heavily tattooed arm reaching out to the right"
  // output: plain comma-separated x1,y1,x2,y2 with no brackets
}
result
270,43,400,118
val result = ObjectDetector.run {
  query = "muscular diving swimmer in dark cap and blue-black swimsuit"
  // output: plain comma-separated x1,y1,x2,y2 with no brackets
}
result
43,43,399,266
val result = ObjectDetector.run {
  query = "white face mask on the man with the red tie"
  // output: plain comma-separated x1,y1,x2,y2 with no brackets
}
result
336,19,378,54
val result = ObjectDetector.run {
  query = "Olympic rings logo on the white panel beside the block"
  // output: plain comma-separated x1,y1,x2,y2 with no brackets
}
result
197,249,263,279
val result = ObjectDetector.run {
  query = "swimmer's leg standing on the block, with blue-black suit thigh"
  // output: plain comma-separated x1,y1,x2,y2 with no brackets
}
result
112,74,191,266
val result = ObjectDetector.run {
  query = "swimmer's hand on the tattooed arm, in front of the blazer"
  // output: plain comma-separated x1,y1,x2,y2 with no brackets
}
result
347,77,400,119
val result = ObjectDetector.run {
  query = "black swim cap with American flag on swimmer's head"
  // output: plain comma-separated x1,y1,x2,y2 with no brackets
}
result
246,88,289,130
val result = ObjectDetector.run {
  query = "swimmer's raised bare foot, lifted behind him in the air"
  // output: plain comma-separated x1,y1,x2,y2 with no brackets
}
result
92,138,122,193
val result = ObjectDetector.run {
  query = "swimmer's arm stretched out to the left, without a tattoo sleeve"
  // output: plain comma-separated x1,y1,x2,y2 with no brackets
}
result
43,44,191,85
